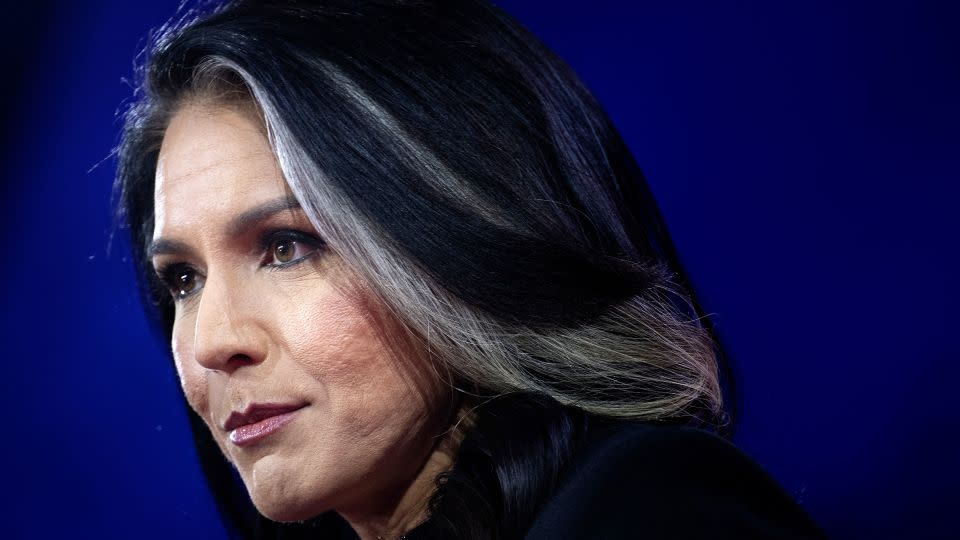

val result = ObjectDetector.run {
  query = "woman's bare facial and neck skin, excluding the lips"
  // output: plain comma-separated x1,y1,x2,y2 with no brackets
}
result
152,102,456,538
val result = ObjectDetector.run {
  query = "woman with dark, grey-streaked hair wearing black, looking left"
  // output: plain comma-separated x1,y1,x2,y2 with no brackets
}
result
118,0,821,539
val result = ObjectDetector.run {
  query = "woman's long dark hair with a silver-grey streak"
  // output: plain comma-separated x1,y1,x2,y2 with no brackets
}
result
117,0,733,538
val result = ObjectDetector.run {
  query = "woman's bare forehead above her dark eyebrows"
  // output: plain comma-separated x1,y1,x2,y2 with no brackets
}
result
154,105,289,237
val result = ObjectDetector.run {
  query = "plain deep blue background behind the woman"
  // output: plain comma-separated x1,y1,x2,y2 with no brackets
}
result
0,0,960,539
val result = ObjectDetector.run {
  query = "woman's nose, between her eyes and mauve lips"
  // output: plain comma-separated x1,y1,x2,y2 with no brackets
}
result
193,268,266,372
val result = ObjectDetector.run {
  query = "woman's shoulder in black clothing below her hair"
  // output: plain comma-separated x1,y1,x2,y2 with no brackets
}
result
527,424,824,540
